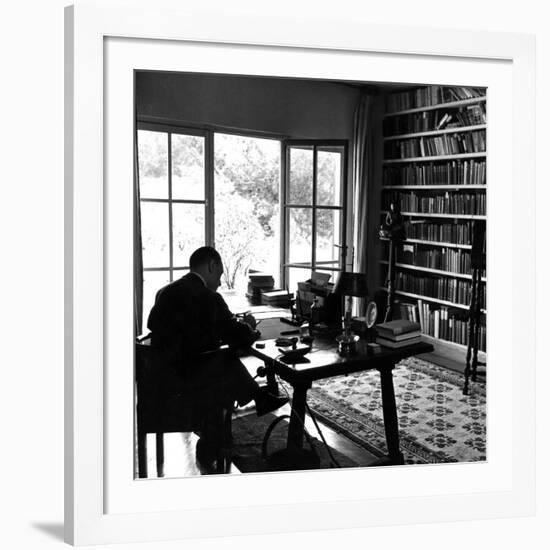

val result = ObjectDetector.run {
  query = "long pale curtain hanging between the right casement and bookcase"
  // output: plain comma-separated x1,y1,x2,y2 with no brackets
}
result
352,93,376,315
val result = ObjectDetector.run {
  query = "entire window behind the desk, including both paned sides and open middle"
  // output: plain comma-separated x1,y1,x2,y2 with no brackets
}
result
138,128,346,328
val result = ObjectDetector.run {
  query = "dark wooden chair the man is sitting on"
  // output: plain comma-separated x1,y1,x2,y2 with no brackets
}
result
135,334,233,478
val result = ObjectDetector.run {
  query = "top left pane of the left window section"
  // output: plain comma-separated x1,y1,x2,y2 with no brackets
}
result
138,130,168,199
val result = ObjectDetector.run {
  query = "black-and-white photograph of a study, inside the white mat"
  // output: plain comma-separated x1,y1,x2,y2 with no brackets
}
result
133,70,488,479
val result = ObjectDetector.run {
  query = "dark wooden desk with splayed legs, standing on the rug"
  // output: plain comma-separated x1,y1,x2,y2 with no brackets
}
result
251,339,433,465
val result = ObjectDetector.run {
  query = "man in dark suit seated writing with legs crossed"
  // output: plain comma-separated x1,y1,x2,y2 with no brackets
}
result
147,246,288,470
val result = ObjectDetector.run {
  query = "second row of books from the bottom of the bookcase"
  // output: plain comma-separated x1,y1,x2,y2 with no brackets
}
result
395,271,487,309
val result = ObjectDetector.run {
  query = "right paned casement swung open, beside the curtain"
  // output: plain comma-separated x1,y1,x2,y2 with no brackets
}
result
282,140,346,292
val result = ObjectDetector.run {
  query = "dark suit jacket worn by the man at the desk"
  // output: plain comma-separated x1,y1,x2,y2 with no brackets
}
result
147,273,256,368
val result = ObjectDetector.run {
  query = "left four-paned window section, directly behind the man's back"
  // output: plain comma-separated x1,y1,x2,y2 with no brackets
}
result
138,126,207,319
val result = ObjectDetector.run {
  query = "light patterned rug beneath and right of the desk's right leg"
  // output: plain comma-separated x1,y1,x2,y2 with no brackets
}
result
308,357,486,464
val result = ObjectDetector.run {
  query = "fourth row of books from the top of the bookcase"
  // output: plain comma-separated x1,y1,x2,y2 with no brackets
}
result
383,159,487,186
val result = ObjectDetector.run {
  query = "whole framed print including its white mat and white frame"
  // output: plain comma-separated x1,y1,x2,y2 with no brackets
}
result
65,2,535,545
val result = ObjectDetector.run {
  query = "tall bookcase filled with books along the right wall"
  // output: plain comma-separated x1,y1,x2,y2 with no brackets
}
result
381,86,487,362
